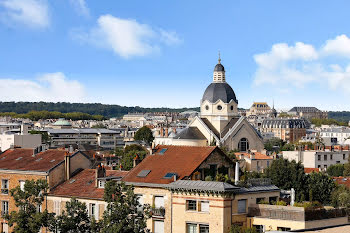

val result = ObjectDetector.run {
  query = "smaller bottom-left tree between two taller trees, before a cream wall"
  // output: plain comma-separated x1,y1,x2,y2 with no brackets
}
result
49,198,93,233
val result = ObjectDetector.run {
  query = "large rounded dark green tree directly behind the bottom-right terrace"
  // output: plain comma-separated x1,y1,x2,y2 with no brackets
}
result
265,158,308,201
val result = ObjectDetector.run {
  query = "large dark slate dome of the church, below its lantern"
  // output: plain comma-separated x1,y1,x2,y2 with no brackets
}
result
202,82,238,104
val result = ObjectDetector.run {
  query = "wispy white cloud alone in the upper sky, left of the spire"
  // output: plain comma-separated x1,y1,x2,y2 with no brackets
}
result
72,15,182,58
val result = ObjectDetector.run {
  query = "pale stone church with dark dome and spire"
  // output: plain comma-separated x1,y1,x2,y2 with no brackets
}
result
155,57,264,151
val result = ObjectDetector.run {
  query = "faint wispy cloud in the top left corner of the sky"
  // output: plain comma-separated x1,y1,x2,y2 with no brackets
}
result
0,0,50,28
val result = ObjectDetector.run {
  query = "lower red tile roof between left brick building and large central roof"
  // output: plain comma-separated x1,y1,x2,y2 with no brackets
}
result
49,169,128,199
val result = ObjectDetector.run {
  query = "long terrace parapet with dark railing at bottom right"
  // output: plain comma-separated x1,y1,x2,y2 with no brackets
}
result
248,204,347,221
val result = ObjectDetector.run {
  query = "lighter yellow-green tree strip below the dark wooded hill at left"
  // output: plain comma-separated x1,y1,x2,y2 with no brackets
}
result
0,111,105,121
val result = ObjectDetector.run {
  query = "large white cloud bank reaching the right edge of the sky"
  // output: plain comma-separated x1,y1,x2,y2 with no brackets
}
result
254,35,350,94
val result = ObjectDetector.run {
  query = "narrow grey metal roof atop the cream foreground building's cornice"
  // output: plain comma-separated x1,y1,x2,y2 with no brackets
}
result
167,180,240,192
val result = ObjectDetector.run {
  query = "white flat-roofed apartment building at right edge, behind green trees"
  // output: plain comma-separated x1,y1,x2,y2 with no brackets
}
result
282,149,350,170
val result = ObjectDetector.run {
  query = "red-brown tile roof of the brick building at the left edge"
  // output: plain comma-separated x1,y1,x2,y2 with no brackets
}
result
0,149,72,172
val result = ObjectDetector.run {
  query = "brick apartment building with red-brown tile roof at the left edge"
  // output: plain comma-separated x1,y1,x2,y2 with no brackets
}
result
0,149,90,233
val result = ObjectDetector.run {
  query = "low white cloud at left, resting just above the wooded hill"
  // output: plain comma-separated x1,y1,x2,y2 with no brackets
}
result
0,72,86,102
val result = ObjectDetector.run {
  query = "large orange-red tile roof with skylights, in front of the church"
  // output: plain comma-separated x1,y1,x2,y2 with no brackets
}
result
123,145,217,184
